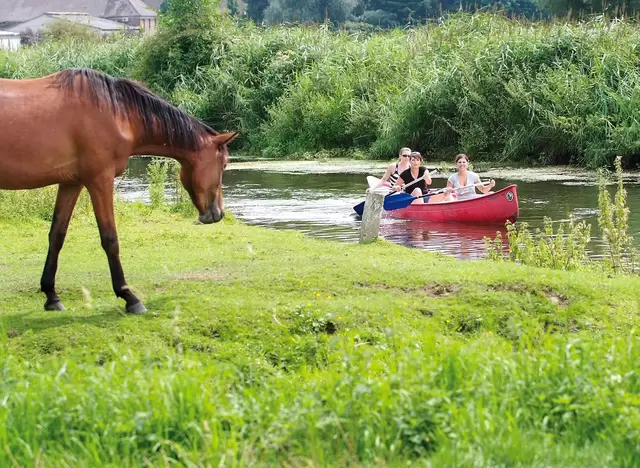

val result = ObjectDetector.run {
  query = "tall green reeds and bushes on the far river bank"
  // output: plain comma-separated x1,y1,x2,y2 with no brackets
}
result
0,14,640,167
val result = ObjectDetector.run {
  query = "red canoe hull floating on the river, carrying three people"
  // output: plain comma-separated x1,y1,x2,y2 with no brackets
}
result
387,185,519,223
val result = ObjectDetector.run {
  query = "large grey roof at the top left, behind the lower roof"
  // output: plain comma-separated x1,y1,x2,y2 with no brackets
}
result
0,0,155,23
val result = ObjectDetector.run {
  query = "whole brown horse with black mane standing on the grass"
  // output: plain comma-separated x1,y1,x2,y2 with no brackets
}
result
0,69,238,313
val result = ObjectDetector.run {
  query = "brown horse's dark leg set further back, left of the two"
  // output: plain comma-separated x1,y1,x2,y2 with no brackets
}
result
40,184,82,310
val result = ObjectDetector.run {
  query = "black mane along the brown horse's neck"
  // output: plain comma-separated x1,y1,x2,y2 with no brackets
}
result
55,68,218,151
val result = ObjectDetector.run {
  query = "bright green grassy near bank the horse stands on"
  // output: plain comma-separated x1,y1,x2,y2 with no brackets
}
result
0,205,640,466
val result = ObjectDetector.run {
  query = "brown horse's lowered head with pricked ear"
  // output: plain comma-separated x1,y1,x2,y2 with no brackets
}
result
180,132,239,224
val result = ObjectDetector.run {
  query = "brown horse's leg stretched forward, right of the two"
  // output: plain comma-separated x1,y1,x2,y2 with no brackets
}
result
87,177,147,314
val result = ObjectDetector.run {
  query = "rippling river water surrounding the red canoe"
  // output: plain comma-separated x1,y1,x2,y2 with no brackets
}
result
118,158,640,259
